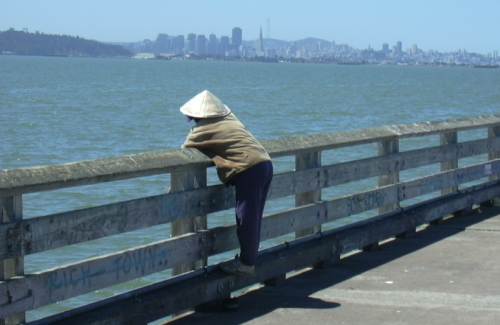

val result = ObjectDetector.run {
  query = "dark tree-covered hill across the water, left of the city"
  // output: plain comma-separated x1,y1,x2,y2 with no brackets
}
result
0,29,131,57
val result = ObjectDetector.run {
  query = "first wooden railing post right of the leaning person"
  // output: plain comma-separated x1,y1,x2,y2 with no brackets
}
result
295,151,321,238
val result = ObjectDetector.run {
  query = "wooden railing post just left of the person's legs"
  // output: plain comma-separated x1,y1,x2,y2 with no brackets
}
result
170,169,207,275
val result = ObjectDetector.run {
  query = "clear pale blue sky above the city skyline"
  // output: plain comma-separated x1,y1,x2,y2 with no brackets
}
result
0,0,500,53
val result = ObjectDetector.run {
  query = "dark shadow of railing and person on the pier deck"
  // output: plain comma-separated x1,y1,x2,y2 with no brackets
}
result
168,207,500,325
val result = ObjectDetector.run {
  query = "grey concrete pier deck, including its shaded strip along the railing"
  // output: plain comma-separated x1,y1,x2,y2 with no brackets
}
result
171,208,500,325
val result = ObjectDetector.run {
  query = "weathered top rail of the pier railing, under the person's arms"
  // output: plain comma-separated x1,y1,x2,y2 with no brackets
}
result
0,115,500,197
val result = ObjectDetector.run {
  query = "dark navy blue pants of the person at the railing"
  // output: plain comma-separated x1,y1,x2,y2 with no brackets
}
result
231,161,273,265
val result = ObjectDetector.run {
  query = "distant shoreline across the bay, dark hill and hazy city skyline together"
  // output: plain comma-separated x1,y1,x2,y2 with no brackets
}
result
0,27,500,67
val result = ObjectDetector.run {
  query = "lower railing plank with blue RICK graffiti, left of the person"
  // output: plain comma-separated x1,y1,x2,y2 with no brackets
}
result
0,232,210,317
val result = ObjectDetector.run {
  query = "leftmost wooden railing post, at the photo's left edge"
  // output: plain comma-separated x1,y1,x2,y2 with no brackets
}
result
0,194,25,325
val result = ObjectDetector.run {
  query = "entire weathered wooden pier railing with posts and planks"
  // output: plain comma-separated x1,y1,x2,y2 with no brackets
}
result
0,115,500,324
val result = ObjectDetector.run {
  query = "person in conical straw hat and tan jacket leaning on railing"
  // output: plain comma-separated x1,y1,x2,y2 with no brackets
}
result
180,90,273,274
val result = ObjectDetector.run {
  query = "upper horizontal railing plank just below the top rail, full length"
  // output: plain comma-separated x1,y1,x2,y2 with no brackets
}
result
0,139,500,258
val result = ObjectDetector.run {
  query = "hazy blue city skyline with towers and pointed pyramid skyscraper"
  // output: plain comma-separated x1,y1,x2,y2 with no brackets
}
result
102,27,500,67
